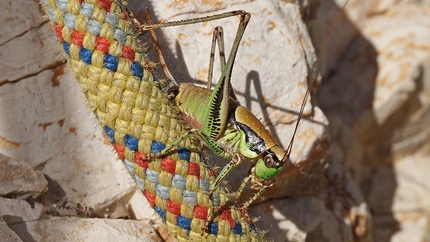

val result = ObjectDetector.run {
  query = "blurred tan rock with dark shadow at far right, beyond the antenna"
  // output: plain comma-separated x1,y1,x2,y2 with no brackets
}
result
312,0,430,241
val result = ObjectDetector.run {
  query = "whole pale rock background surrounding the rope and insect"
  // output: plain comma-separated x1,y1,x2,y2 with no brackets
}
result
0,0,430,242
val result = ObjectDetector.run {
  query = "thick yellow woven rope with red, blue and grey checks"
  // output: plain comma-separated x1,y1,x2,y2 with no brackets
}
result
38,0,263,241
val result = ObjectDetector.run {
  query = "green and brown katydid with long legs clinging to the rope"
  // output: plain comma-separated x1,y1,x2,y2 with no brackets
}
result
135,0,346,229
